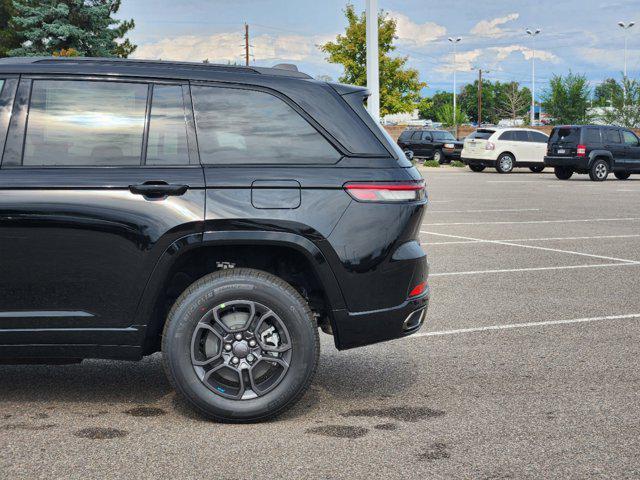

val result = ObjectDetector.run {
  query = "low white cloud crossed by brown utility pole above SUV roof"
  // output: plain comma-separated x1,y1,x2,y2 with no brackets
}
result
134,32,325,63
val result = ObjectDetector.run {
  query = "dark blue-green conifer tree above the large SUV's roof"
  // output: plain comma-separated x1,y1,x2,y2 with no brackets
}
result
9,0,136,58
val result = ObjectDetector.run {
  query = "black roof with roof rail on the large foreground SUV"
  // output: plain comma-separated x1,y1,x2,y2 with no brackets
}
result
0,57,311,79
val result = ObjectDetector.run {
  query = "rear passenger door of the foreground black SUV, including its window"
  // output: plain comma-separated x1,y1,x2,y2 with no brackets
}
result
0,76,204,353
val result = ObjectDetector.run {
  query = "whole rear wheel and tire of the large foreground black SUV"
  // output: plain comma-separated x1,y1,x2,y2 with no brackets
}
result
162,268,320,423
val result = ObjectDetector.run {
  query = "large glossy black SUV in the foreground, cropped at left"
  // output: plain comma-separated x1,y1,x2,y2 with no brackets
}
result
0,58,429,421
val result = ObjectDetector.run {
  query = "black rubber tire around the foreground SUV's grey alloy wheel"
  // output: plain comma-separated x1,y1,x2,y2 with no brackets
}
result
163,277,318,421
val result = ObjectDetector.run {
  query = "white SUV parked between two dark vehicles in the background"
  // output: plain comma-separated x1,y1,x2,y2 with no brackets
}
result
461,127,549,173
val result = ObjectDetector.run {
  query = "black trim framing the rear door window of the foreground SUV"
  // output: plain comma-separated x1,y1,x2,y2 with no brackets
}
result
0,74,200,170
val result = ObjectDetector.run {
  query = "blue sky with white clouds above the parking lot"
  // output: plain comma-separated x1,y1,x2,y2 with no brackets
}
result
118,0,640,95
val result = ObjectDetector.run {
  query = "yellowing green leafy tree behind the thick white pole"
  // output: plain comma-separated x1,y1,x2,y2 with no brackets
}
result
320,4,426,115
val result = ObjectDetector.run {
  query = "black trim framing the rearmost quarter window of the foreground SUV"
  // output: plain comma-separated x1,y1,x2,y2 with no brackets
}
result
189,80,344,161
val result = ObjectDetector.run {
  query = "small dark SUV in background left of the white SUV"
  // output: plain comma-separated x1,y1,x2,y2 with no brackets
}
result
398,128,463,163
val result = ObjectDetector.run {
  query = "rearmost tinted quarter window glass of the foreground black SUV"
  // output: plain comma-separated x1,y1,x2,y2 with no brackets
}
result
192,87,339,164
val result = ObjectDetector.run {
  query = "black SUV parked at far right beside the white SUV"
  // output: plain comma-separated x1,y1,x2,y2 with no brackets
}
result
544,125,640,182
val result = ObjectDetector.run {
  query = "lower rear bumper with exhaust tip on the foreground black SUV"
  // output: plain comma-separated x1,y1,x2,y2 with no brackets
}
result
333,287,430,350
